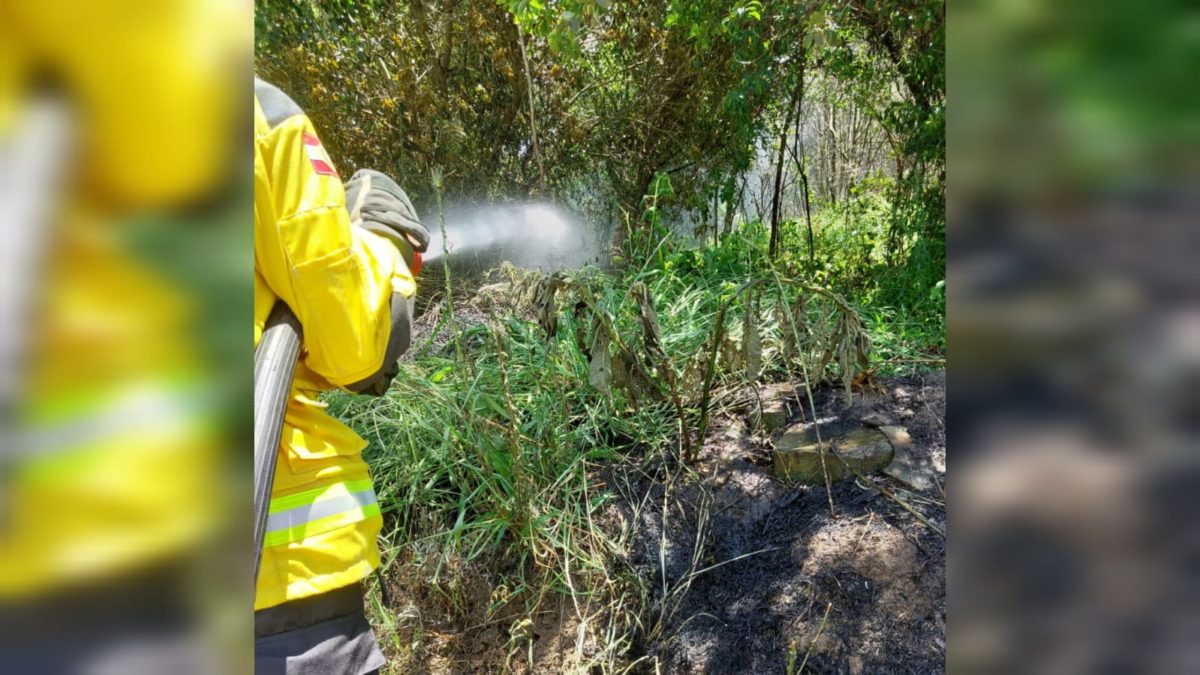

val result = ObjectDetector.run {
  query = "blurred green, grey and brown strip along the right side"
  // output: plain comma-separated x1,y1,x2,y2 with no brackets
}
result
947,0,1200,673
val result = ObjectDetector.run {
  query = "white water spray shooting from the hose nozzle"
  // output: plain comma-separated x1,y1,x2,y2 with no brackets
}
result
424,202,607,271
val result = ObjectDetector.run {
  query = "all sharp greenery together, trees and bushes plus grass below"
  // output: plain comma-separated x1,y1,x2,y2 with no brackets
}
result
256,0,946,671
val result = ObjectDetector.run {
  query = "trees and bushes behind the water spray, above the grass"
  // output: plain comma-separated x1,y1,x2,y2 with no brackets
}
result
256,0,946,289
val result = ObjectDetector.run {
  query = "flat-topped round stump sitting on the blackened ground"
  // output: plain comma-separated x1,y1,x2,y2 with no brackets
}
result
775,426,894,485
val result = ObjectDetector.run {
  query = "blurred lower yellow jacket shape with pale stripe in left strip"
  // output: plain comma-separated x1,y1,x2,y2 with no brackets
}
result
0,230,220,599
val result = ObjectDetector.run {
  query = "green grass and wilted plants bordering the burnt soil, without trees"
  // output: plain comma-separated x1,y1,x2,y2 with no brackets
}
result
326,225,942,673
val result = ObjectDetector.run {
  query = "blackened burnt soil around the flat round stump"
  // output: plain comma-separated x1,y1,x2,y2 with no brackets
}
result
611,374,946,673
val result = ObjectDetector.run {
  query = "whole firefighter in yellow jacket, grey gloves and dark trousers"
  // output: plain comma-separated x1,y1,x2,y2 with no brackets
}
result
254,78,428,675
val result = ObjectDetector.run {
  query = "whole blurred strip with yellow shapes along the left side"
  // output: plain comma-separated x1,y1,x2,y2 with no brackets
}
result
0,0,253,673
